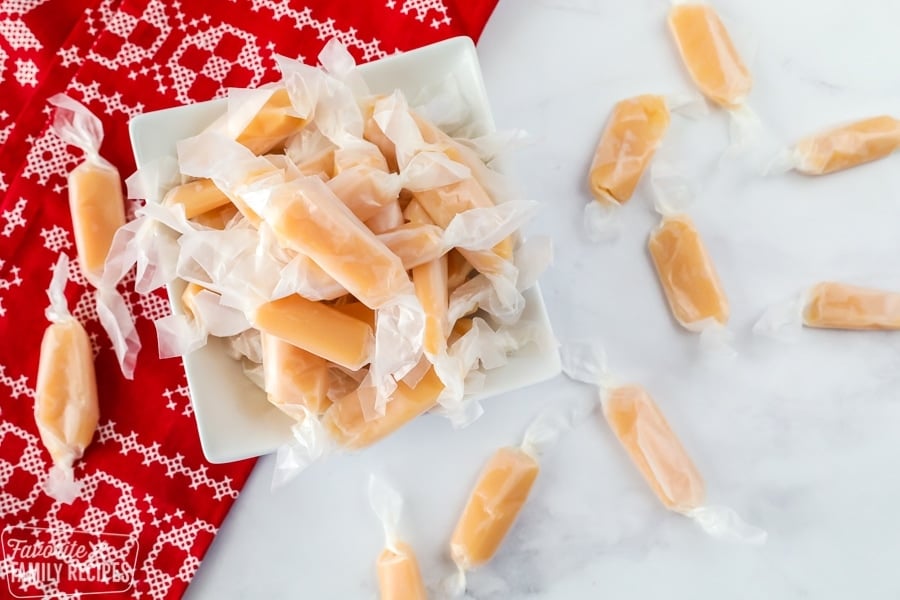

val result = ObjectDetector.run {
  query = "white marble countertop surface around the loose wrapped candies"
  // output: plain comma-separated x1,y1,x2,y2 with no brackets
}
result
186,0,900,600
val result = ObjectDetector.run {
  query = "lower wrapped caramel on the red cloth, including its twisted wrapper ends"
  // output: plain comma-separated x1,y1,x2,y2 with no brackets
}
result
34,254,100,504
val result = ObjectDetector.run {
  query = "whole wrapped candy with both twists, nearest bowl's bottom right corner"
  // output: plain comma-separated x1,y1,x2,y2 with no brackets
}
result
561,343,766,544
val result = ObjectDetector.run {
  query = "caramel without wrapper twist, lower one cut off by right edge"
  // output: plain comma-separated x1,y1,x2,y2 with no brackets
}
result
803,282,900,330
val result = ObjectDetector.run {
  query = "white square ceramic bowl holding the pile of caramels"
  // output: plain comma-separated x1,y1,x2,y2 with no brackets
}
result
129,37,560,463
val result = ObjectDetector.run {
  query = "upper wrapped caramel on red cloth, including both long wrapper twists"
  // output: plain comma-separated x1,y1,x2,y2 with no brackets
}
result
48,94,141,379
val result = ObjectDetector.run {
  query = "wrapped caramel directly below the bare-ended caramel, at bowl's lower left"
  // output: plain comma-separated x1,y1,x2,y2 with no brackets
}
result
260,332,331,421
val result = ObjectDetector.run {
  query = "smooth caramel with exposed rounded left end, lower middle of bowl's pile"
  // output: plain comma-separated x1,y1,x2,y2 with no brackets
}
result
250,295,375,371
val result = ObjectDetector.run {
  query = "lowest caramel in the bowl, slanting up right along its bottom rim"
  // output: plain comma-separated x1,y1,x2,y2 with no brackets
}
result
323,369,444,449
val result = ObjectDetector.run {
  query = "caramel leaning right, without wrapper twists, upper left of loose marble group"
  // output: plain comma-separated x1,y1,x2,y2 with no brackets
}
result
589,95,669,204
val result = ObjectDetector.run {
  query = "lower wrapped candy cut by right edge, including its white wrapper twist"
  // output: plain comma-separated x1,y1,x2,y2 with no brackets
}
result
753,281,900,341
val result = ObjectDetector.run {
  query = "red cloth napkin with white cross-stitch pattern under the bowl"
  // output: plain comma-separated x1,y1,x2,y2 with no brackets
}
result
0,0,496,599
